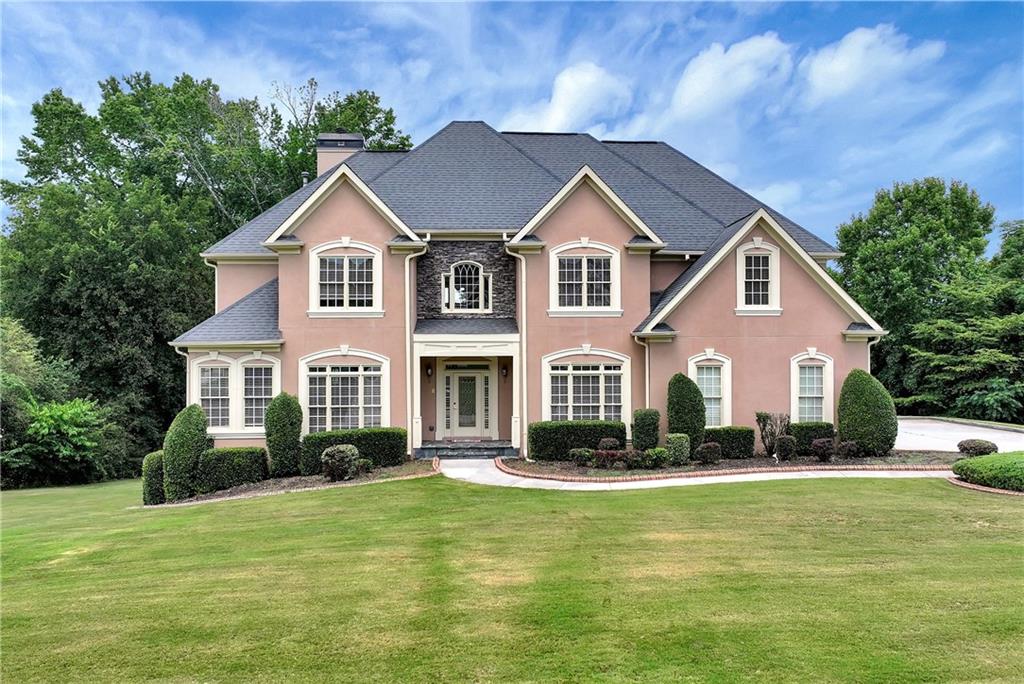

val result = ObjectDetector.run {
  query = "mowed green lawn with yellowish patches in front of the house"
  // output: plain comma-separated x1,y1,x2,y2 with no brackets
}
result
6,477,1024,682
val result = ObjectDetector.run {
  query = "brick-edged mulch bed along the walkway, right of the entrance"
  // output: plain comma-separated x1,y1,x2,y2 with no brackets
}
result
498,452,964,481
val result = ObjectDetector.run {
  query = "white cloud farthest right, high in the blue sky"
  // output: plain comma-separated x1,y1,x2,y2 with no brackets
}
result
799,24,946,108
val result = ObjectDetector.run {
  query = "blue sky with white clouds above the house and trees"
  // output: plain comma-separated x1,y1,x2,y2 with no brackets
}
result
0,3,1024,249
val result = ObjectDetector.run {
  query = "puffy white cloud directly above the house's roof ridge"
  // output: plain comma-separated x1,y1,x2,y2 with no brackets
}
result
501,61,633,131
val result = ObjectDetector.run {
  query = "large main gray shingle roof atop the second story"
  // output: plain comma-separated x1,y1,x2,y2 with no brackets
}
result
206,121,835,255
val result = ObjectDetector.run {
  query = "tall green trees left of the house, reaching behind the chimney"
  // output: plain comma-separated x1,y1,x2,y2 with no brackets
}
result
0,74,410,455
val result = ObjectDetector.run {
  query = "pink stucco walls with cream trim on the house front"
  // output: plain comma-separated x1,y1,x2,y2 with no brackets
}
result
187,168,869,456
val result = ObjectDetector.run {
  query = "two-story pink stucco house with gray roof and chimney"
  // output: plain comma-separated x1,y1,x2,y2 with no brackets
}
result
172,122,885,453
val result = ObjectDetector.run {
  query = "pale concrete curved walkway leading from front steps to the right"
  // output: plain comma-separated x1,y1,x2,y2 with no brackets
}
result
440,459,953,491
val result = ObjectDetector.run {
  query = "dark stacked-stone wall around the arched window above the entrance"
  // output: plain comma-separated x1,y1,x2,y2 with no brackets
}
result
416,240,516,318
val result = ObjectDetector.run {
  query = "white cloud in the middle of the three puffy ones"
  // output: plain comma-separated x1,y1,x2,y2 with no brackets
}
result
672,32,793,120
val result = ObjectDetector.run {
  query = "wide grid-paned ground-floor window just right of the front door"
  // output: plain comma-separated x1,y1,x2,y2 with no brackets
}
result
550,364,623,421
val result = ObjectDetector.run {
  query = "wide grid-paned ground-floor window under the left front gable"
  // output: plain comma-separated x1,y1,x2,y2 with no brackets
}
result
308,365,382,432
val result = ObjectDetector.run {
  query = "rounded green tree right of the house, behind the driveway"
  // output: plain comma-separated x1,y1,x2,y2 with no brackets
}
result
838,178,994,405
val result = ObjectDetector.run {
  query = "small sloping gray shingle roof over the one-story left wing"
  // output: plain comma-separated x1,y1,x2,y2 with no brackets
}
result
171,279,282,346
